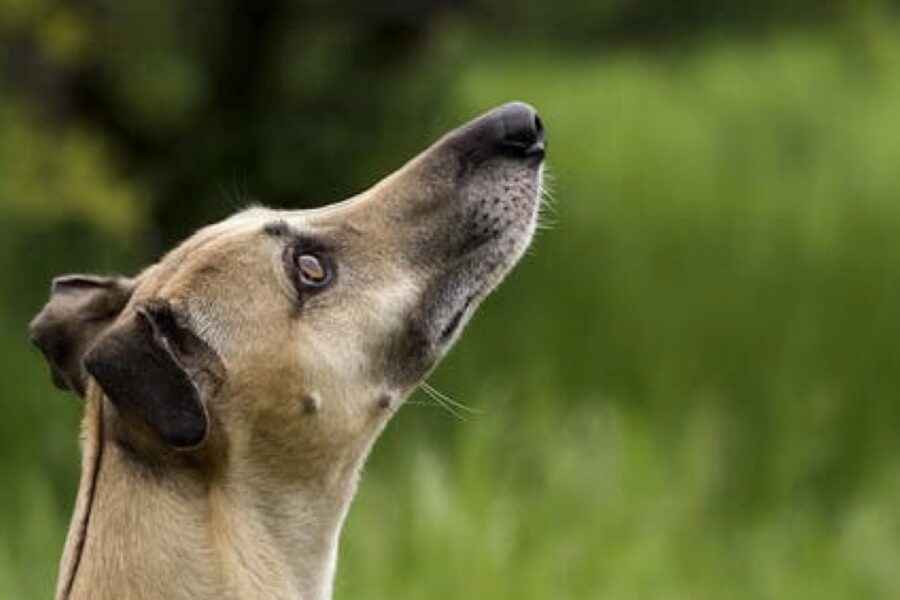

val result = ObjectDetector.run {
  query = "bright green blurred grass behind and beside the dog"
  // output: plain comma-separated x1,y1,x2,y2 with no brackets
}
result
0,25,900,600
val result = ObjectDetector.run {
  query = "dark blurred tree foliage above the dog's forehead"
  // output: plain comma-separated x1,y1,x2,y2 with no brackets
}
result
0,0,458,244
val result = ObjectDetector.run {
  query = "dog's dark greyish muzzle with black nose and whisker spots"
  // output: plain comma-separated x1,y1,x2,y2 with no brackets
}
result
382,102,547,382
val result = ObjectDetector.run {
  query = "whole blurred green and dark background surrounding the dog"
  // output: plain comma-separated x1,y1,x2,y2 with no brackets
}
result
0,0,900,600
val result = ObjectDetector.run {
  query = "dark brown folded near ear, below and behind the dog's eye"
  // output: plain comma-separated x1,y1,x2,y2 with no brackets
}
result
84,303,209,449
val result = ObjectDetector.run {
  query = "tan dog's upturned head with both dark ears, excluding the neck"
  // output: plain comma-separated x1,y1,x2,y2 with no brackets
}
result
31,103,545,470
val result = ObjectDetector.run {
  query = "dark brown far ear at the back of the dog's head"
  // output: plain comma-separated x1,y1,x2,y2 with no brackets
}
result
29,275,134,397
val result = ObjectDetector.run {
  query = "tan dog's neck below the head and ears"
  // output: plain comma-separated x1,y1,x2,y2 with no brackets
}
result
57,397,370,600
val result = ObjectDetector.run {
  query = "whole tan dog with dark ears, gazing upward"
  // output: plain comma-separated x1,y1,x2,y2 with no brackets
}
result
30,103,546,600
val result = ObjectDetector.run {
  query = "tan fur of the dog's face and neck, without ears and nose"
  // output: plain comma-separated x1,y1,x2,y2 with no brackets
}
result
31,104,540,600
